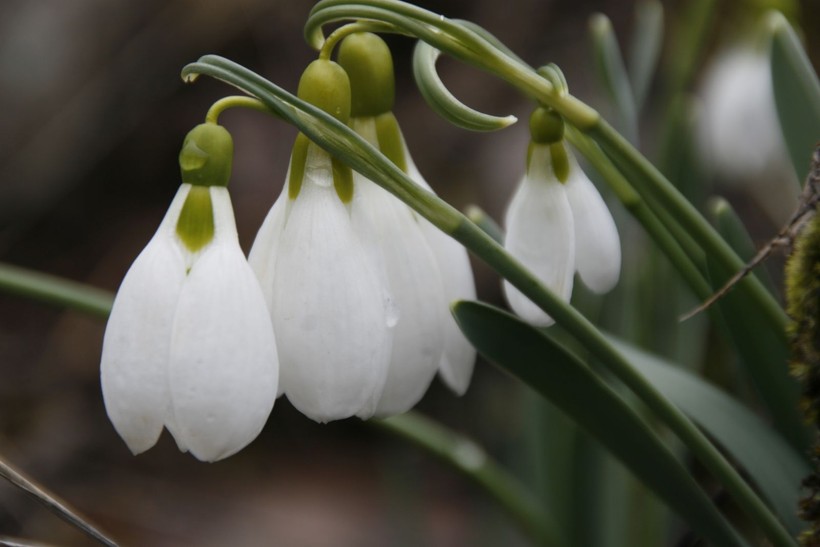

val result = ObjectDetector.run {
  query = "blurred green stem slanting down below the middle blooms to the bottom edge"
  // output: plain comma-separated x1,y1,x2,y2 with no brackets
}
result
370,411,567,546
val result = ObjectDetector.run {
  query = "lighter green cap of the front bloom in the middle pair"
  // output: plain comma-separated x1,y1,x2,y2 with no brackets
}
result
297,59,350,123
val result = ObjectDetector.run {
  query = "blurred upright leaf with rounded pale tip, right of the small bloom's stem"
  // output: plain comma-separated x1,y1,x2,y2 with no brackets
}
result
589,13,638,143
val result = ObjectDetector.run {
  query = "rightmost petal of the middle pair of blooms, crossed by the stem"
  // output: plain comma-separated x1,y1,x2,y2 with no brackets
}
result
404,152,476,395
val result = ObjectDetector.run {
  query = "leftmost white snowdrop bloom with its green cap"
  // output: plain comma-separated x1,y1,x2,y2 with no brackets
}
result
101,124,278,461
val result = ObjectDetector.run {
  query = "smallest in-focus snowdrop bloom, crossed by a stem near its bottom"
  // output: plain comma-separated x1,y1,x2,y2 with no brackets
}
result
503,108,621,326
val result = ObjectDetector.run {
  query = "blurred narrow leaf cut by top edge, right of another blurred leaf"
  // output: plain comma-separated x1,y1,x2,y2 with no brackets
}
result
629,0,663,112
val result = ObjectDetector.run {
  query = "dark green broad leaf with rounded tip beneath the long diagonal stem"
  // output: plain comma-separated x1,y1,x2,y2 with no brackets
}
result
453,302,743,545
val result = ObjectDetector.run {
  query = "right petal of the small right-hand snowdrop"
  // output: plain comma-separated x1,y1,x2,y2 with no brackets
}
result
566,150,621,294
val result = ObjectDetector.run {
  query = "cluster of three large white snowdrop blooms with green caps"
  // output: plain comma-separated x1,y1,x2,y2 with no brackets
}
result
101,30,475,461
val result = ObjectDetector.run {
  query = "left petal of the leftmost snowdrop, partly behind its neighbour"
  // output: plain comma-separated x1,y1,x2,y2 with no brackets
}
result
100,185,190,454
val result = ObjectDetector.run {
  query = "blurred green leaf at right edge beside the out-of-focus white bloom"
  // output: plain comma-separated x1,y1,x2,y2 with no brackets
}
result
768,12,820,181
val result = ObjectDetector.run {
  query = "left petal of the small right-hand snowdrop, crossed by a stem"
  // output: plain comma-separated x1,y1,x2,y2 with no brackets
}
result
503,146,575,326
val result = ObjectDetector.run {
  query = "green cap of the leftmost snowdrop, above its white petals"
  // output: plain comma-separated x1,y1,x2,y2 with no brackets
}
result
179,123,233,186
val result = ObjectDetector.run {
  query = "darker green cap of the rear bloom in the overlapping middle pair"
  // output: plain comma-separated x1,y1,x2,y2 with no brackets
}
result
339,32,396,117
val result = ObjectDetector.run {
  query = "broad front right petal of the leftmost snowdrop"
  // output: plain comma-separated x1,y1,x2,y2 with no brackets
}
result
170,187,279,461
